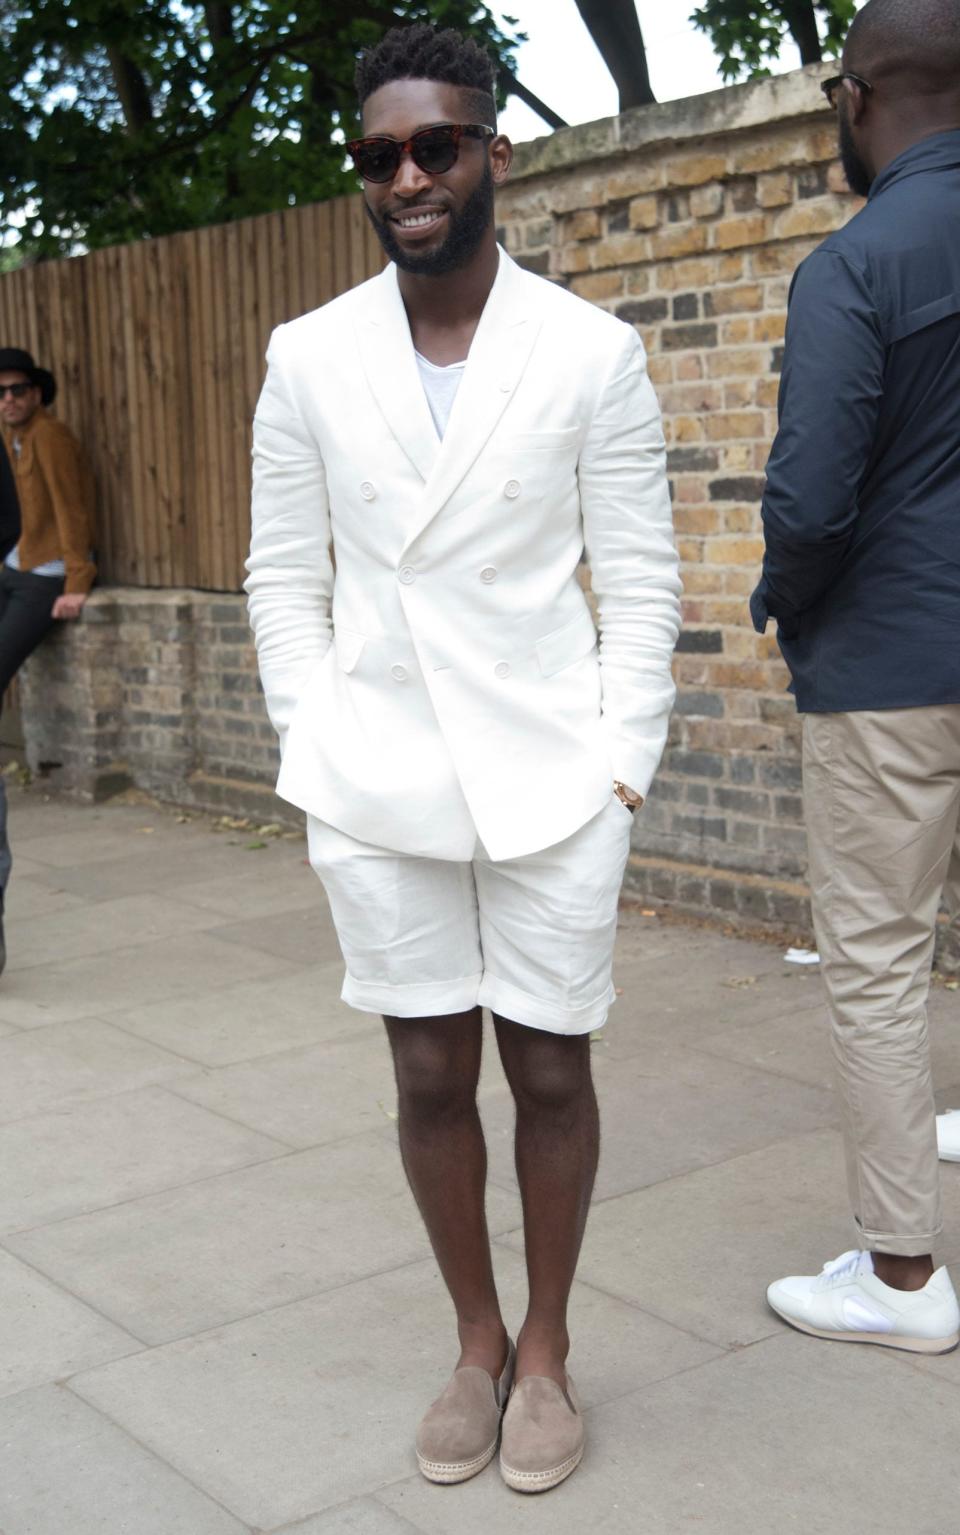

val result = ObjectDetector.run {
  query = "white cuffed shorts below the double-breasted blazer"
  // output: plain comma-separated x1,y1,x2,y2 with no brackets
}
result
307,797,631,1035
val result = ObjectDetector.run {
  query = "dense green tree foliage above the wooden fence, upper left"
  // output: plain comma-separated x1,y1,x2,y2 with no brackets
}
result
0,0,528,256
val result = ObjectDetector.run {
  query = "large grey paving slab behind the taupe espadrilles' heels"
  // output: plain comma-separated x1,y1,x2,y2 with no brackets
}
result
71,1262,705,1529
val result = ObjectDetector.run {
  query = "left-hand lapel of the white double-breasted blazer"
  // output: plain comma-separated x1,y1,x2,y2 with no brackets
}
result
356,264,441,480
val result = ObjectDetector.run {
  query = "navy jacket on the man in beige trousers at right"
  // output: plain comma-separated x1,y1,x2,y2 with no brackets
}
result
751,132,960,714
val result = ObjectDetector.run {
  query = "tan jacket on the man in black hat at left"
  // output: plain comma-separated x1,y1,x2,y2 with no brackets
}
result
3,405,97,593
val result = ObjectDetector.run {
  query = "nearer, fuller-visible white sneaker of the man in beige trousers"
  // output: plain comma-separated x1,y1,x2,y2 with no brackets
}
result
766,1249,960,1354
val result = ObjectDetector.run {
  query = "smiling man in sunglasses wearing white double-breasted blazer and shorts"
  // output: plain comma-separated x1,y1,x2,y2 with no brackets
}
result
246,26,680,1492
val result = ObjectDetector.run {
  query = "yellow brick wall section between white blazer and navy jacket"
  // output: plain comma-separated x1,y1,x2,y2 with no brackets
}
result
498,66,859,923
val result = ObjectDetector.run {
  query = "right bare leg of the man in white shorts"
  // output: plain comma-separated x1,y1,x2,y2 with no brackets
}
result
493,1016,599,1386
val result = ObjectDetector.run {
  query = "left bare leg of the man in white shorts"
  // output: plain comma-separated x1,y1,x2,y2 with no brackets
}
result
384,1007,507,1377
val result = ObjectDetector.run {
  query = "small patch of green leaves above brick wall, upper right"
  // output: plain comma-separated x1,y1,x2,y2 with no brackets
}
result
691,0,857,80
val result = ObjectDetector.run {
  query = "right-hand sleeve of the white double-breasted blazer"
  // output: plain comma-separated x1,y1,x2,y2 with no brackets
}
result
578,330,682,795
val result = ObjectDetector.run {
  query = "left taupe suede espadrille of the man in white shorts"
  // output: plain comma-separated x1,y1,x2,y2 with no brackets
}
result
416,1342,516,1484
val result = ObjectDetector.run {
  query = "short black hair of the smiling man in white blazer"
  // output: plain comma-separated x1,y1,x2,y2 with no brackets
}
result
355,21,496,127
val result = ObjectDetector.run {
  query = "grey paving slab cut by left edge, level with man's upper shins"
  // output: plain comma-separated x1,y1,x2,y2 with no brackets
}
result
0,1087,287,1234
